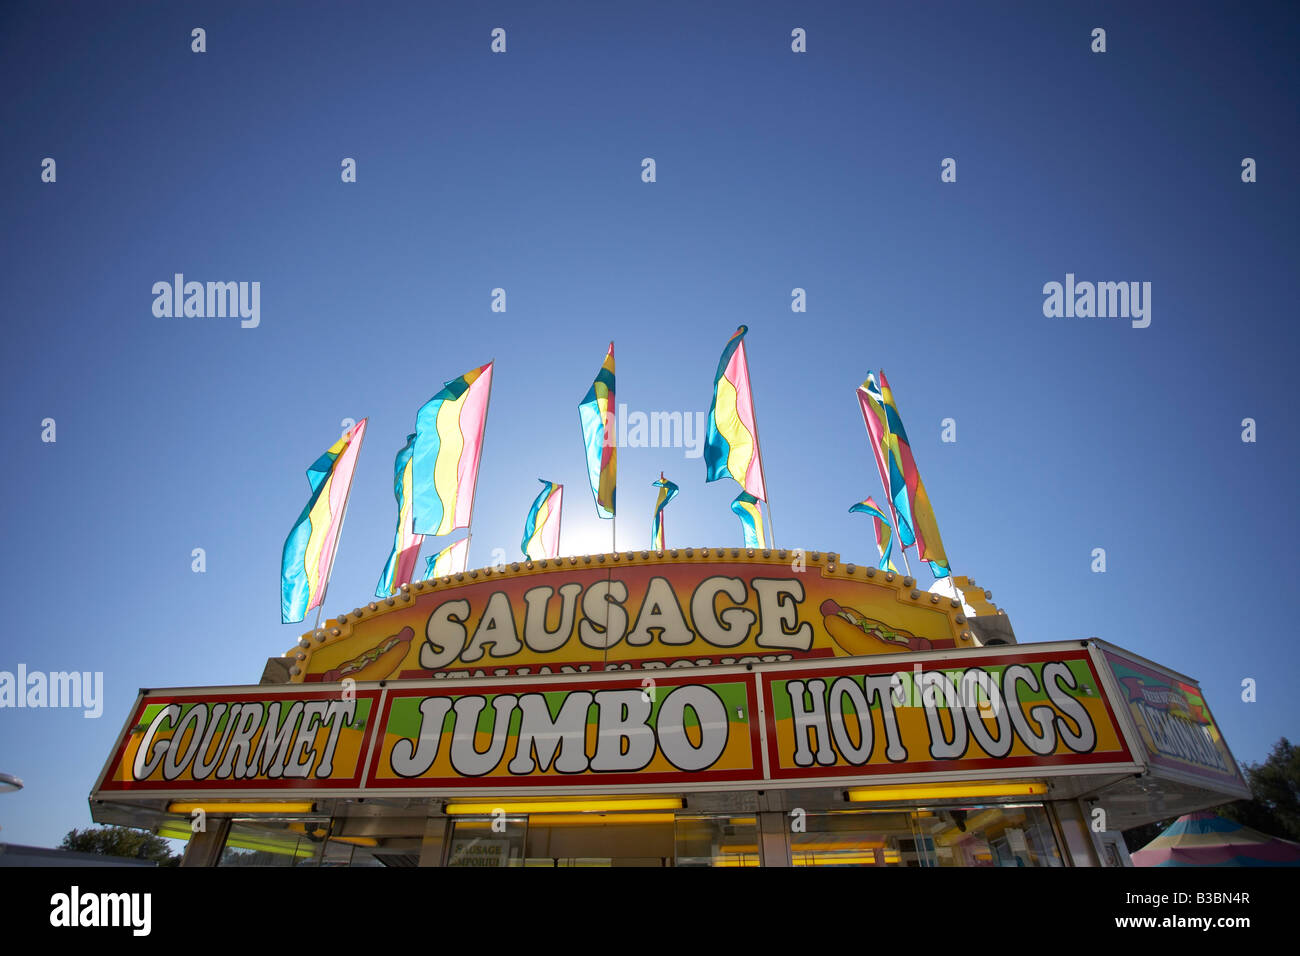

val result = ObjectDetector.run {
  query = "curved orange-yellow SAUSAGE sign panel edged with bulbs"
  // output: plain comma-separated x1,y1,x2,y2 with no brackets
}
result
287,549,978,683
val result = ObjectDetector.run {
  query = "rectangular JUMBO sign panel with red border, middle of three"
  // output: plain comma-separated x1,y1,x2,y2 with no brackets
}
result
367,675,762,788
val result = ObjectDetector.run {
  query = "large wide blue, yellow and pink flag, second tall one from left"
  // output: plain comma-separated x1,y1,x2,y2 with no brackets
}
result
412,362,493,535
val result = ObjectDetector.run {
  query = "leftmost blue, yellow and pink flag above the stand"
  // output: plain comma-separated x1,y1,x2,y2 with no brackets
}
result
280,419,367,624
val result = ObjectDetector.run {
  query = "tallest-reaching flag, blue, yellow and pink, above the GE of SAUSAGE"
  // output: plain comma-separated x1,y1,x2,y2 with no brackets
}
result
705,325,767,501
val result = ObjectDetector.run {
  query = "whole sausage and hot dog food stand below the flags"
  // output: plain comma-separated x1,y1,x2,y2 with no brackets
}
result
91,549,1248,866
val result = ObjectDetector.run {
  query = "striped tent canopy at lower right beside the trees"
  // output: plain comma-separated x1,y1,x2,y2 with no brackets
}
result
1132,810,1300,866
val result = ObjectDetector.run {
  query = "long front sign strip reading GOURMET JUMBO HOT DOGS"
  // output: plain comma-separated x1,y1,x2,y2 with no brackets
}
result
96,644,1196,799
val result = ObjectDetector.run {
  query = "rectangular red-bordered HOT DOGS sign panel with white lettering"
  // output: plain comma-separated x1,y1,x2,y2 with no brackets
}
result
762,648,1132,779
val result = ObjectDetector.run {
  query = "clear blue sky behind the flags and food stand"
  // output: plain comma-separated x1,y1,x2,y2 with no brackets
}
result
0,3,1300,845
